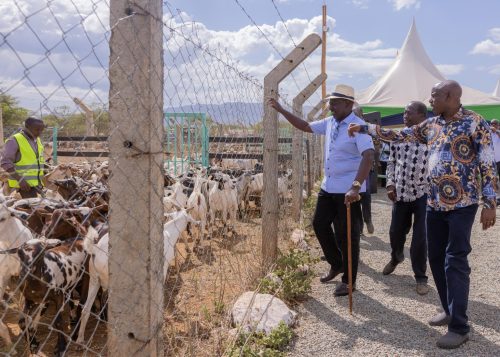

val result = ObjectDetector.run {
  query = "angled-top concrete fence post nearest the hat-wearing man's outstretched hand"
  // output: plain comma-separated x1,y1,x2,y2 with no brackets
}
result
262,34,321,270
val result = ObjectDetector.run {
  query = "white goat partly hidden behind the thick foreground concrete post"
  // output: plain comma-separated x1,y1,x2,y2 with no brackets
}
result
76,209,200,344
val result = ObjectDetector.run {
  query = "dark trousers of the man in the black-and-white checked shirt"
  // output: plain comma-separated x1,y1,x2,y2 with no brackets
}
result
389,195,427,283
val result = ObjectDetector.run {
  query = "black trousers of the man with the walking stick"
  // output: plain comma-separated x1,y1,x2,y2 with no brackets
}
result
313,190,361,284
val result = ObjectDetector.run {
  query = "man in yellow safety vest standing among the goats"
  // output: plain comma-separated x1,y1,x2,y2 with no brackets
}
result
1,117,45,198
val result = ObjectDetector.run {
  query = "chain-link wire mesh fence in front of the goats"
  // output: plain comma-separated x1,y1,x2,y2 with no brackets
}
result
0,0,322,356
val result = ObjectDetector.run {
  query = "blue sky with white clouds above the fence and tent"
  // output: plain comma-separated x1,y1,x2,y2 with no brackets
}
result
0,0,500,110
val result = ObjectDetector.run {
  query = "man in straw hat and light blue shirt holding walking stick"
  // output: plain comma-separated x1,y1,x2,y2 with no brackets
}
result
268,84,374,296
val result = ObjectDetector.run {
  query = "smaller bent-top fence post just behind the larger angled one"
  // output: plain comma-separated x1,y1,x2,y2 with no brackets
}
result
292,74,326,221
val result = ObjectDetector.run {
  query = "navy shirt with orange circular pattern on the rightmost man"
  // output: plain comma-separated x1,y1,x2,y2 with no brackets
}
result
368,108,498,211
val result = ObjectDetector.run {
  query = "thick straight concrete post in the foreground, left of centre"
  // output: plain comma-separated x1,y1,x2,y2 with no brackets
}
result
107,0,164,356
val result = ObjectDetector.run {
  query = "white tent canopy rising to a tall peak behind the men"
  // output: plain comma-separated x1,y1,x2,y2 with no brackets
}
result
357,20,500,107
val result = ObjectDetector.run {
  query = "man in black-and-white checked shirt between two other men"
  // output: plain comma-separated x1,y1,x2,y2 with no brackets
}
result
382,101,429,295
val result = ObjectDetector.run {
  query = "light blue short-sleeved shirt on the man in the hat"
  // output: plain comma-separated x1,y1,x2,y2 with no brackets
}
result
309,113,373,193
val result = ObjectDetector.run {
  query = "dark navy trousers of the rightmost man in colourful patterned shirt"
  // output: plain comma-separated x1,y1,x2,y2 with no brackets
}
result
427,205,477,334
